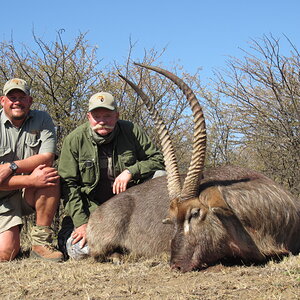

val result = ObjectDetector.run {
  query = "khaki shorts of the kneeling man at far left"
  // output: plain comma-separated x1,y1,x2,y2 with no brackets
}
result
0,191,35,233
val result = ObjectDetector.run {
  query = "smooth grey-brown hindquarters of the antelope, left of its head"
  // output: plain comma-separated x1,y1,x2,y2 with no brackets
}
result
87,176,173,260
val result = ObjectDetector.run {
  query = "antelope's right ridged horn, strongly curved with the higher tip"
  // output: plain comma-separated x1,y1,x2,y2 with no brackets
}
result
135,63,206,200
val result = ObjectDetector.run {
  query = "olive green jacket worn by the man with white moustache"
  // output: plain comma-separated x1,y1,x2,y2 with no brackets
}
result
58,120,164,227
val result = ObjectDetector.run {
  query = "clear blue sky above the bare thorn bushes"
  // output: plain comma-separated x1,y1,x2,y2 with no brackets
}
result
0,0,300,80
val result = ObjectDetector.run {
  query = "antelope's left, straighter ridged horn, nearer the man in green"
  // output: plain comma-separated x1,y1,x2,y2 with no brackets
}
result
119,74,181,200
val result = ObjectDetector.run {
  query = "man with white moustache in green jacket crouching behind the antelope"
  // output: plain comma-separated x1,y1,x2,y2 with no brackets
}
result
58,92,165,258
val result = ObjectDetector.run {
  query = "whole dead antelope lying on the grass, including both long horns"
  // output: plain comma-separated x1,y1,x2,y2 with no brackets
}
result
87,65,300,272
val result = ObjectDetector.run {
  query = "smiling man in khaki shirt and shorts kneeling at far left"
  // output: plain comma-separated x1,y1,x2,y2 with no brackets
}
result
0,78,63,261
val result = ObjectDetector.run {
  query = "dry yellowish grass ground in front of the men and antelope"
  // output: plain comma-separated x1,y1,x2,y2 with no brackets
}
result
0,252,300,300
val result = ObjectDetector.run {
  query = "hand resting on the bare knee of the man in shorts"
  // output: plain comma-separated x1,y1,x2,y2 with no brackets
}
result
29,165,59,188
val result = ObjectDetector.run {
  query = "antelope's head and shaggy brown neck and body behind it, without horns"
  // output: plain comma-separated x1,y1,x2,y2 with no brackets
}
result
171,166,300,272
